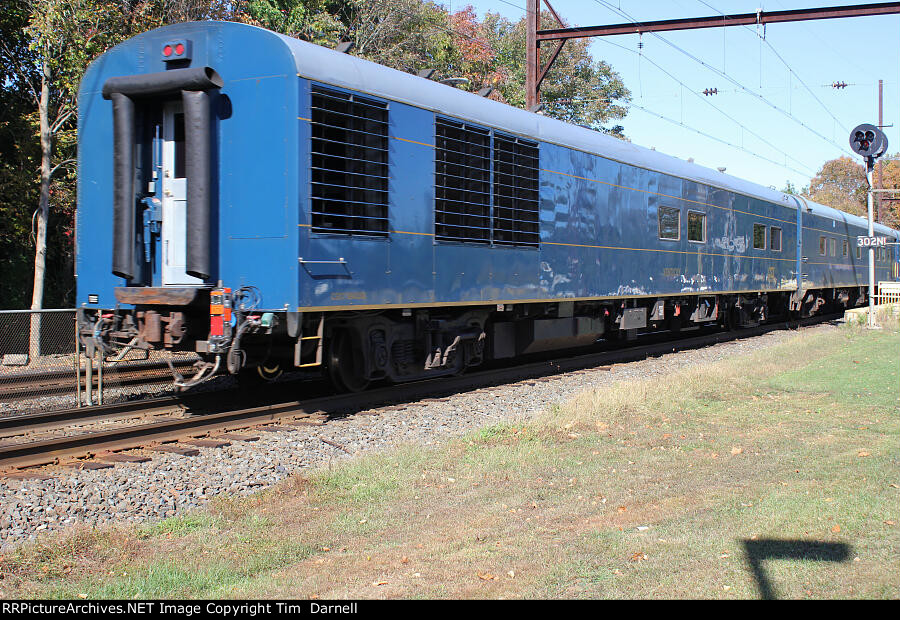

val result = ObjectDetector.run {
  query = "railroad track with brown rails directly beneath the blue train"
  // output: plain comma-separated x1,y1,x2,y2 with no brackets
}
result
0,315,840,475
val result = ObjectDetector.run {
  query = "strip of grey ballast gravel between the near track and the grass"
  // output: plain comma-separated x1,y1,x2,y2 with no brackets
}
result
0,324,838,551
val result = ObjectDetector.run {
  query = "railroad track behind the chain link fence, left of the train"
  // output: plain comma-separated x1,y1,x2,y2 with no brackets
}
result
0,360,194,402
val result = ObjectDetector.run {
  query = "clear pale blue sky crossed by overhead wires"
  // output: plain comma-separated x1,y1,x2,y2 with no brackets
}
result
454,0,900,189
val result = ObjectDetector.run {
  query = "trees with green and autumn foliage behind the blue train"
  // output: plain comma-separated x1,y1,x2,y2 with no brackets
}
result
0,0,900,308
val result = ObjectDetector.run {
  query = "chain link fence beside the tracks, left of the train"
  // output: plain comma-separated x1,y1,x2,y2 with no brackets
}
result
0,309,199,415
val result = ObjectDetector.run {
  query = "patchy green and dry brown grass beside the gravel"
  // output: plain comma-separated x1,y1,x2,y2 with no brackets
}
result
0,327,900,599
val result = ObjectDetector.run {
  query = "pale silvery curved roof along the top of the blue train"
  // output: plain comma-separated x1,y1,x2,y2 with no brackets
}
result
88,22,896,234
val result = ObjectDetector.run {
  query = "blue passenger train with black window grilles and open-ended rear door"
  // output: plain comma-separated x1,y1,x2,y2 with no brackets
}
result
77,22,898,389
